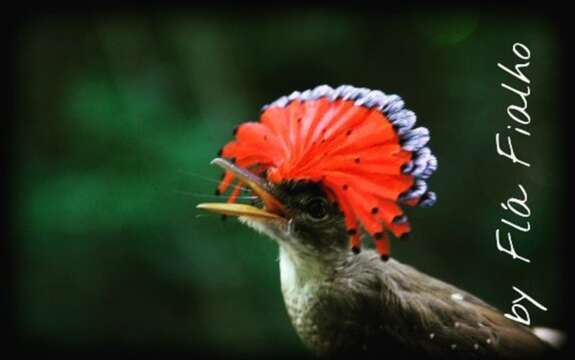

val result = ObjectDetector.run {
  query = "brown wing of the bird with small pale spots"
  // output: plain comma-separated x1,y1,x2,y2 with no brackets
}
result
381,261,549,359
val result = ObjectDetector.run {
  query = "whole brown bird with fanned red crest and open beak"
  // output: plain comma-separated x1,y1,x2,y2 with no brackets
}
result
197,85,565,359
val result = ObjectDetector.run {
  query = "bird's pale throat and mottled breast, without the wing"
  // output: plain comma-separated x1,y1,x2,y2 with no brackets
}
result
279,245,408,354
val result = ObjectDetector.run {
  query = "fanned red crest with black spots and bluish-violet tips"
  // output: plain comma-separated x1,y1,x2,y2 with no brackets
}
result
218,85,437,258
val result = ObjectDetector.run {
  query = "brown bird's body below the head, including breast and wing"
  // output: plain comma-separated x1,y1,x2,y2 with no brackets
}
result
280,249,550,359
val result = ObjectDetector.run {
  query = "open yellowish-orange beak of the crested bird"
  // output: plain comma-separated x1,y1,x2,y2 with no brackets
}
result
196,158,286,221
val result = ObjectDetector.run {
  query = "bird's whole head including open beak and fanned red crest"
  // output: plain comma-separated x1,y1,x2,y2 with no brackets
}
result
198,85,437,260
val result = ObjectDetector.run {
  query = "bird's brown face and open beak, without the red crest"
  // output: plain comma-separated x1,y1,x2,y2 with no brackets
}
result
198,158,349,259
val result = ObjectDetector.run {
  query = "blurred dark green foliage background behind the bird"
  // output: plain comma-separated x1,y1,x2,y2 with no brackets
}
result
14,9,566,354
